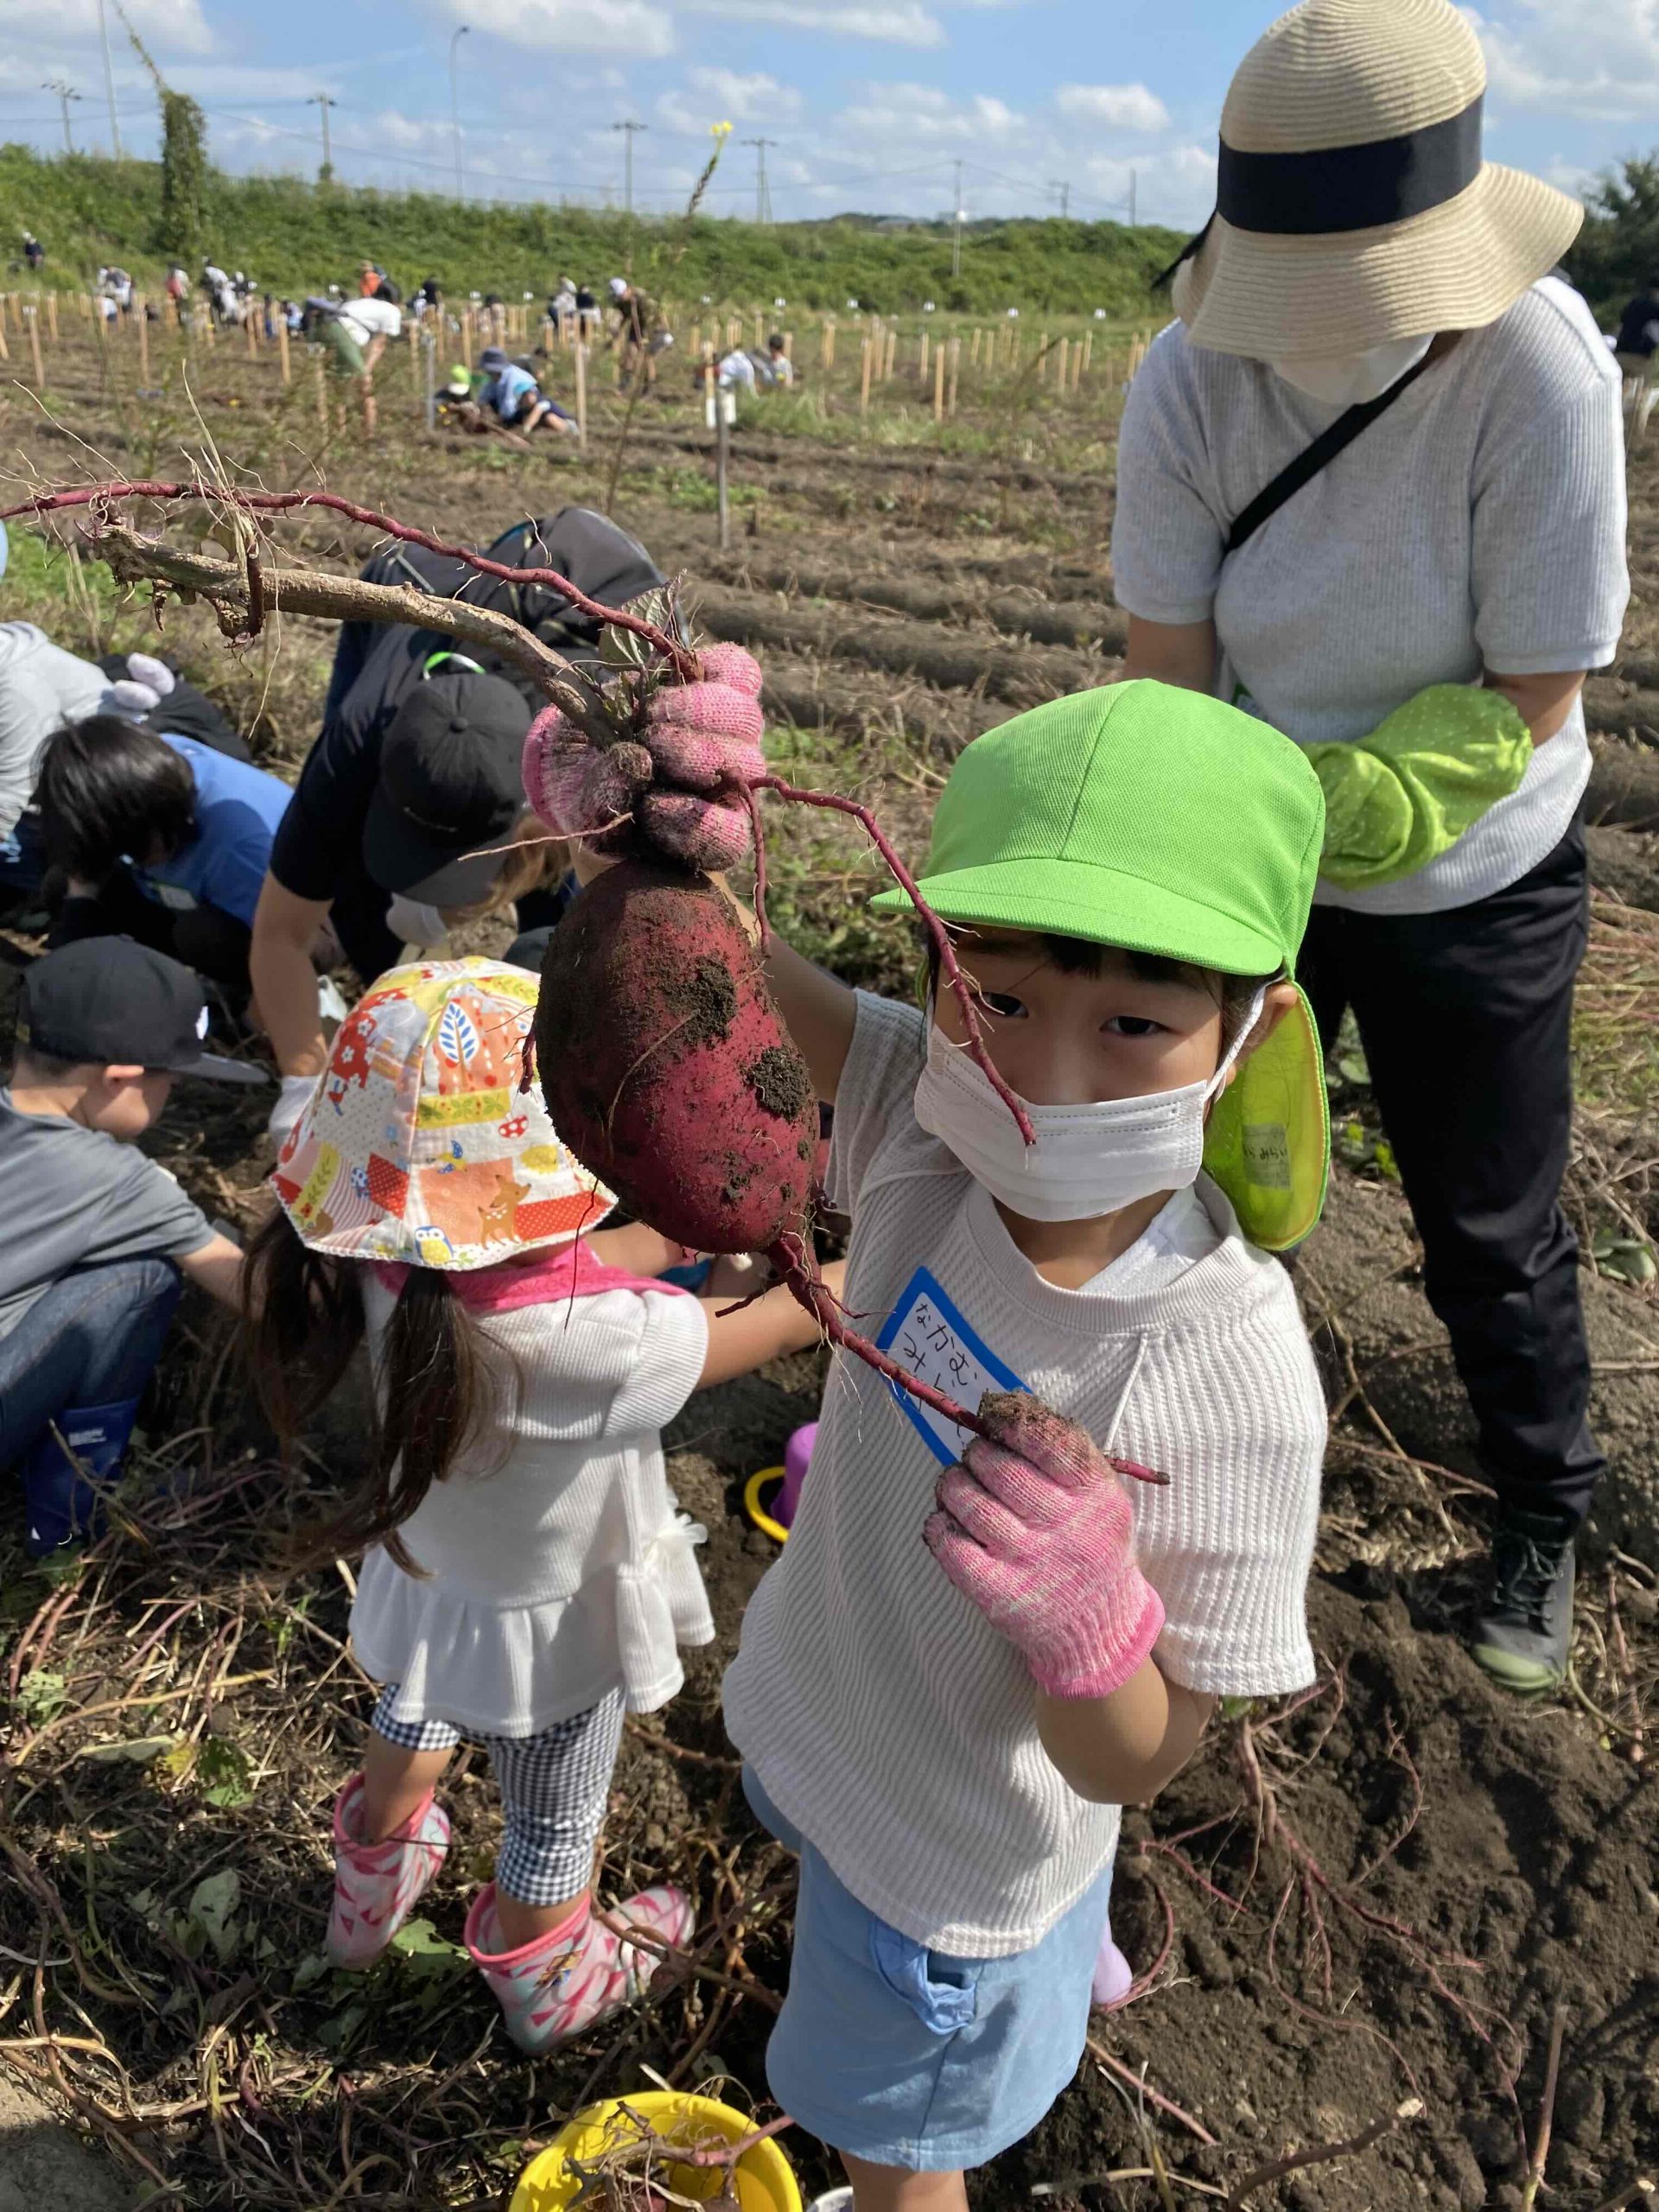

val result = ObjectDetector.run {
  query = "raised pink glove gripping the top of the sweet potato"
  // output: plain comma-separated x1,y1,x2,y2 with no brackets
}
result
524,646,766,869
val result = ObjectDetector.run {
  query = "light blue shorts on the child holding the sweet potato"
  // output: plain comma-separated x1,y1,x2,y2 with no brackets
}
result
743,1767,1113,2172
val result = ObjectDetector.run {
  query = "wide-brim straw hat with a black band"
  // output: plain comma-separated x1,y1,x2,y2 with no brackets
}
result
1170,0,1584,360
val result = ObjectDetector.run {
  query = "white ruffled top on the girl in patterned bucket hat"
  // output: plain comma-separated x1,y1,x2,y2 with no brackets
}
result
352,1269,715,1737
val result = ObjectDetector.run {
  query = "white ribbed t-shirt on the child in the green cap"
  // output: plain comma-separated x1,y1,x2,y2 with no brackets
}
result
726,993,1325,1958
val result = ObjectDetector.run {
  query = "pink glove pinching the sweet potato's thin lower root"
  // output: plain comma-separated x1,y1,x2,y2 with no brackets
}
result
923,1391,1164,1697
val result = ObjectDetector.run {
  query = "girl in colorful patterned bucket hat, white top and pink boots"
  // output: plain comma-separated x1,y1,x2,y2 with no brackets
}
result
248,960,849,2053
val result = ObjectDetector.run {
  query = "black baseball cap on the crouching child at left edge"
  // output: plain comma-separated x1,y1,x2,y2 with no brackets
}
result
17,938,270,1084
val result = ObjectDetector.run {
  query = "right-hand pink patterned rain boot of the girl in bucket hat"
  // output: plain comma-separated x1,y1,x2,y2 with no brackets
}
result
465,1883,695,2057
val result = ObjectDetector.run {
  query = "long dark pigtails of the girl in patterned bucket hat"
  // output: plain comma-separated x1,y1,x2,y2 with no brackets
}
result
241,1208,505,1575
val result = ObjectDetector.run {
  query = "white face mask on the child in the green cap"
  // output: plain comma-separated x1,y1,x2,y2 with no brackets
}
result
916,988,1268,1221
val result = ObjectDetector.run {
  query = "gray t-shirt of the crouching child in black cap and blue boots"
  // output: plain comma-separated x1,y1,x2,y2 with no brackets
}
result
0,1090,214,1336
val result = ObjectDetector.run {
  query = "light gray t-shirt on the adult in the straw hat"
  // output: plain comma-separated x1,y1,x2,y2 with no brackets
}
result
1113,276,1630,913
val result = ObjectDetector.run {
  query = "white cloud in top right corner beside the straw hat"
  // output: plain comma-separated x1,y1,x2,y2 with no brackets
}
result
1460,0,1659,122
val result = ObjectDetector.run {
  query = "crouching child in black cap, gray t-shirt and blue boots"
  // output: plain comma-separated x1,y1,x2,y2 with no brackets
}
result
0,938,256,1560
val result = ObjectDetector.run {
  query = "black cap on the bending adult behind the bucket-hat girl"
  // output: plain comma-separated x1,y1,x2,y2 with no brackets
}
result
363,671,531,907
